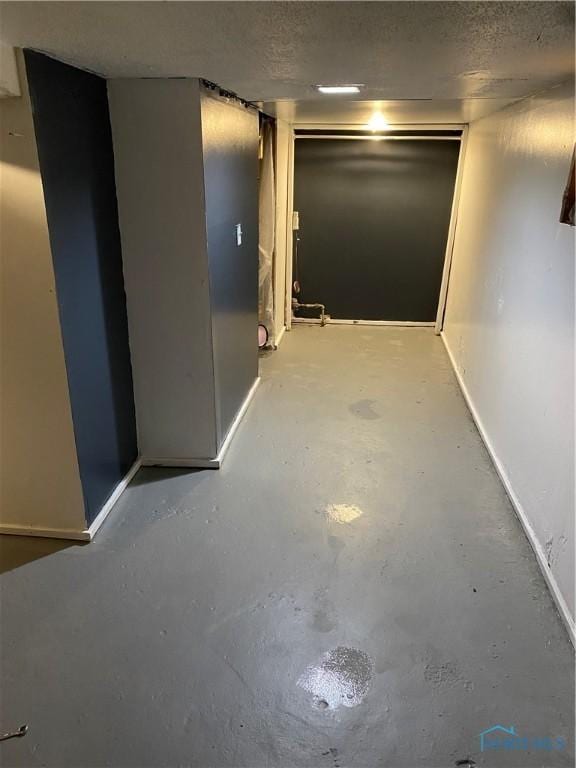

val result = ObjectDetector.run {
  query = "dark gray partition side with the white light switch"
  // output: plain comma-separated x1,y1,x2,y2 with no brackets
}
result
202,94,258,443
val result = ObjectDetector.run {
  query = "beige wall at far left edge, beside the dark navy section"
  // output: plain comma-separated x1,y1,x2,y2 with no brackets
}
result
0,52,86,536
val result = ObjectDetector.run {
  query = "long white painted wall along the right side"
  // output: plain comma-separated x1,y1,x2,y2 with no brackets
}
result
444,83,575,636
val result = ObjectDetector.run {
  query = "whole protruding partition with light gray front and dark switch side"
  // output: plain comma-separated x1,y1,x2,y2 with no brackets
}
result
108,79,258,466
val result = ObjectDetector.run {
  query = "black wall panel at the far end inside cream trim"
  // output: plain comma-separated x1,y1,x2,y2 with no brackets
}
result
294,139,460,322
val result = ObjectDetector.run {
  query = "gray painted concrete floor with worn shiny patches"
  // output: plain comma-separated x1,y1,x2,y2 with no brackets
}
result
0,326,574,768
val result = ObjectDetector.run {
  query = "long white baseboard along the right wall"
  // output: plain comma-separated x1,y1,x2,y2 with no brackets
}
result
440,332,576,647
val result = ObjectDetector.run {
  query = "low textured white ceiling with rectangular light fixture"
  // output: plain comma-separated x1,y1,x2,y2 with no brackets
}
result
0,0,574,122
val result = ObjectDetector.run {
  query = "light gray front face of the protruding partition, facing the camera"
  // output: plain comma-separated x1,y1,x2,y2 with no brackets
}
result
108,80,217,461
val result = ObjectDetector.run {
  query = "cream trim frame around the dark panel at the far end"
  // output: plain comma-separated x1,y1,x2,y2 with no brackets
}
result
285,123,468,335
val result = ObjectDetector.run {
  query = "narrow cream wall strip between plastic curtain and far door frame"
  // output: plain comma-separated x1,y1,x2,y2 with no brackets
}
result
274,120,293,340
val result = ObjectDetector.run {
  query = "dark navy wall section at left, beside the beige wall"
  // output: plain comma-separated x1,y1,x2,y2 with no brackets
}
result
25,51,137,523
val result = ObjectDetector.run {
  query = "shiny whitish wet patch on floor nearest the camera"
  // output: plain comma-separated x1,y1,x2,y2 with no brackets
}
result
298,646,374,709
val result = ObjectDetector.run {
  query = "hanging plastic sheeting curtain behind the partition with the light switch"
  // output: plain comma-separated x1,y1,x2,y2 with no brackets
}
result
258,120,276,345
